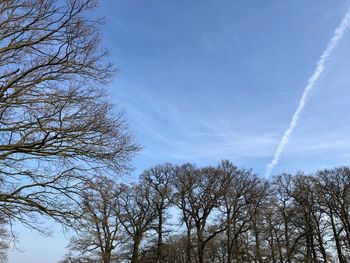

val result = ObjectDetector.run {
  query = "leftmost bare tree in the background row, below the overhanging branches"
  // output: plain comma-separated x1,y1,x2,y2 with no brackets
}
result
69,176,123,263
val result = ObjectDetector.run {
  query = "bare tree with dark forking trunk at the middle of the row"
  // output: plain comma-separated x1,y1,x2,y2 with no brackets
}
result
174,165,225,263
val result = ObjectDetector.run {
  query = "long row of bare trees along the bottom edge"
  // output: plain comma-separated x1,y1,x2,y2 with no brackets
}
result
60,161,350,263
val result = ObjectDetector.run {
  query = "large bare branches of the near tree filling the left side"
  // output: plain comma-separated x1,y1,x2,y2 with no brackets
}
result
0,0,138,230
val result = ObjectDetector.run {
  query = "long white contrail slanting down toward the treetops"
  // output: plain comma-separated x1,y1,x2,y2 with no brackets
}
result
265,6,350,176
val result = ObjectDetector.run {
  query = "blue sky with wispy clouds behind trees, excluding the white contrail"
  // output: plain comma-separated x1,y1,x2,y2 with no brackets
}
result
9,0,350,263
